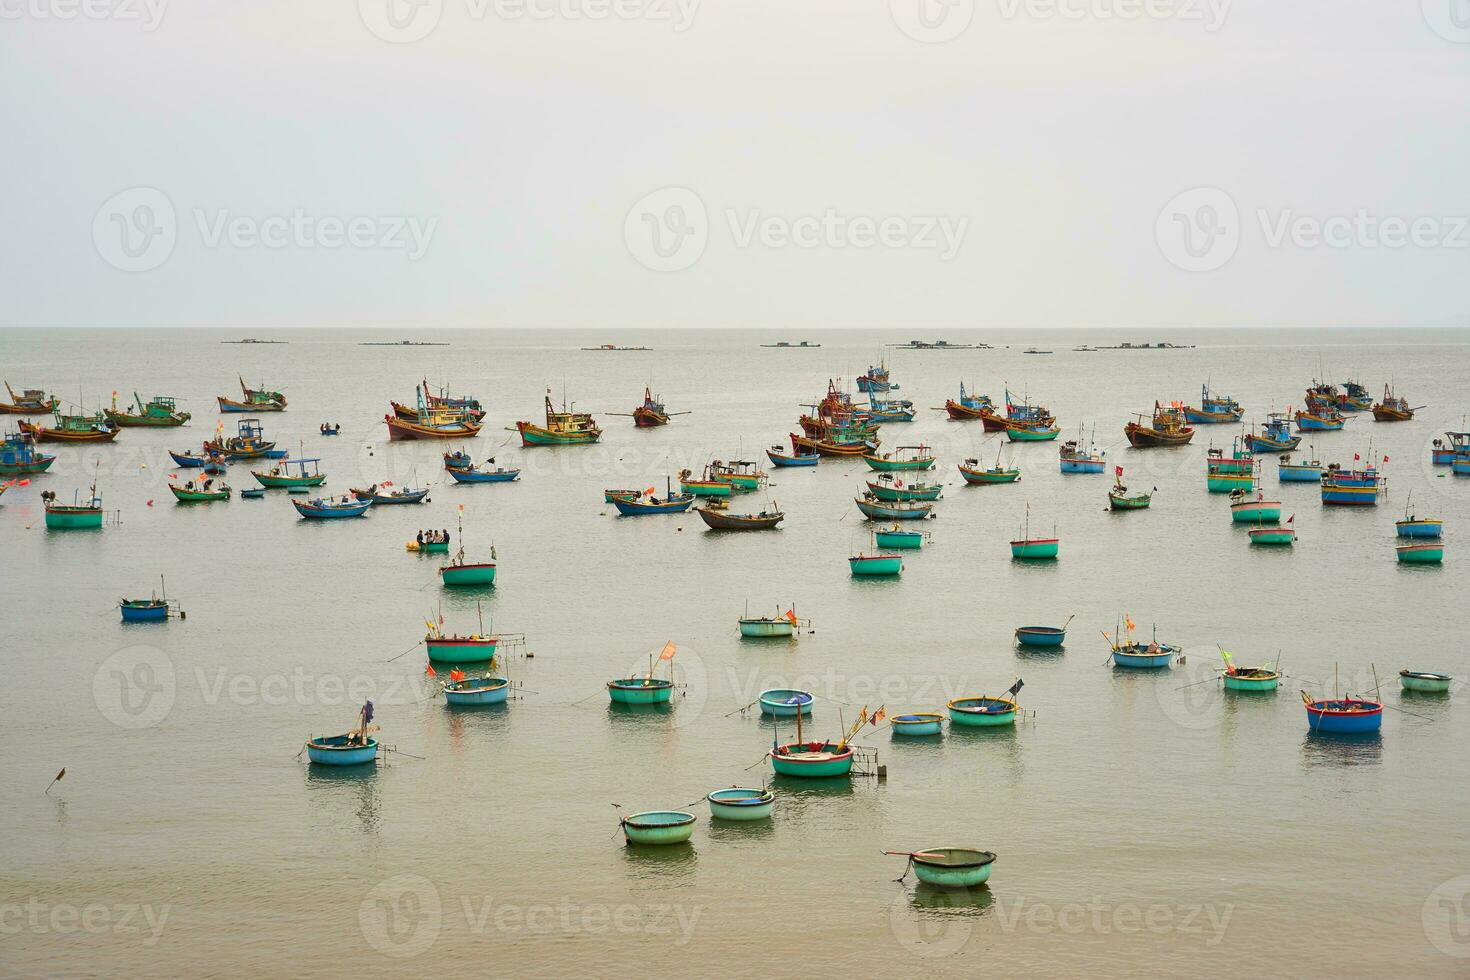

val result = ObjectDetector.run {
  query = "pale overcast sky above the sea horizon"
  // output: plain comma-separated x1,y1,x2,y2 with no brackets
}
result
0,0,1470,328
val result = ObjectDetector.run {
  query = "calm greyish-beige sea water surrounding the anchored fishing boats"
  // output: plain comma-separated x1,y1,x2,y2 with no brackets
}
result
0,331,1470,977
